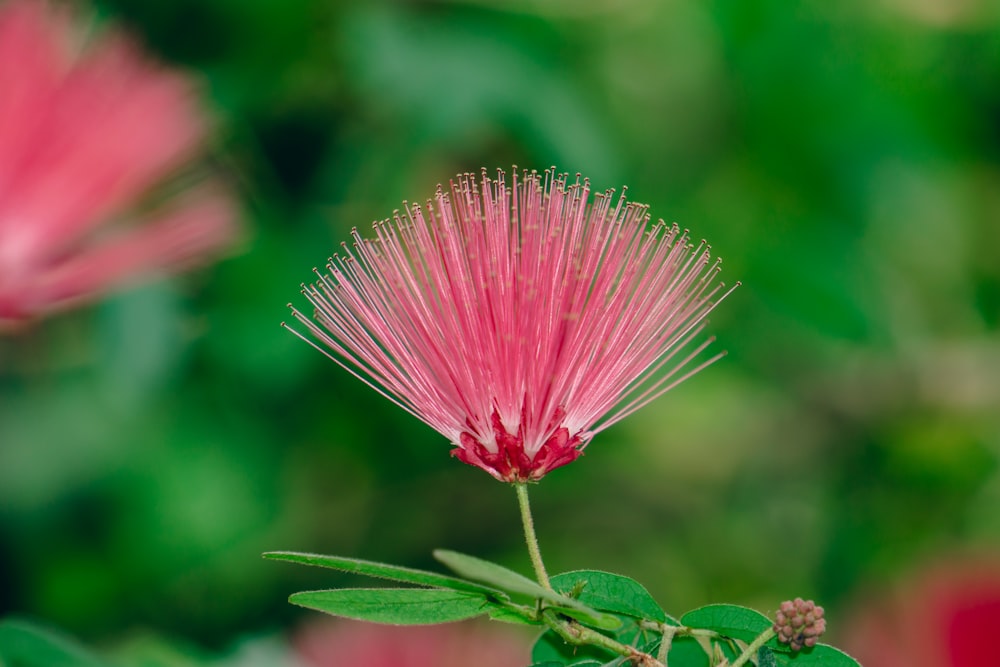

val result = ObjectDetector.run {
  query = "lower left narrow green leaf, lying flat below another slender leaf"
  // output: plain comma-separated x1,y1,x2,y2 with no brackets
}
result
288,588,489,625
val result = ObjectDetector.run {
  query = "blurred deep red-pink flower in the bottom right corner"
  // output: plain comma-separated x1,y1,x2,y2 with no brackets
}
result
839,555,1000,667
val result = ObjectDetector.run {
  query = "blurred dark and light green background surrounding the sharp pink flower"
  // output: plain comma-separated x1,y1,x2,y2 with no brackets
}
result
0,0,1000,665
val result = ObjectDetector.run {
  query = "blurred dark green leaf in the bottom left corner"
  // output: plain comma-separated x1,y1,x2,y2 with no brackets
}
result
0,619,107,667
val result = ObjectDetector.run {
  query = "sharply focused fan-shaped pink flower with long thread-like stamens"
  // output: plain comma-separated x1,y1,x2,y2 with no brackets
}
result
292,166,728,482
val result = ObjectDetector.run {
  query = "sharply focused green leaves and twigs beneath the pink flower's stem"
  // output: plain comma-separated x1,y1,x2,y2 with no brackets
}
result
264,550,860,667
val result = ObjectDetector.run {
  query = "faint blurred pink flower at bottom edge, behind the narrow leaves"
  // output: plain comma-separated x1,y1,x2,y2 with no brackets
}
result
292,620,530,667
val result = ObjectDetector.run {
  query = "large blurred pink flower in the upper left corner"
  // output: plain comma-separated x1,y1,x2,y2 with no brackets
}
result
0,0,235,325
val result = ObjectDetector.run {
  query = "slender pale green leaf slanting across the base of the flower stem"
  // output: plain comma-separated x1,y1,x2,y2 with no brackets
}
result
434,549,621,630
